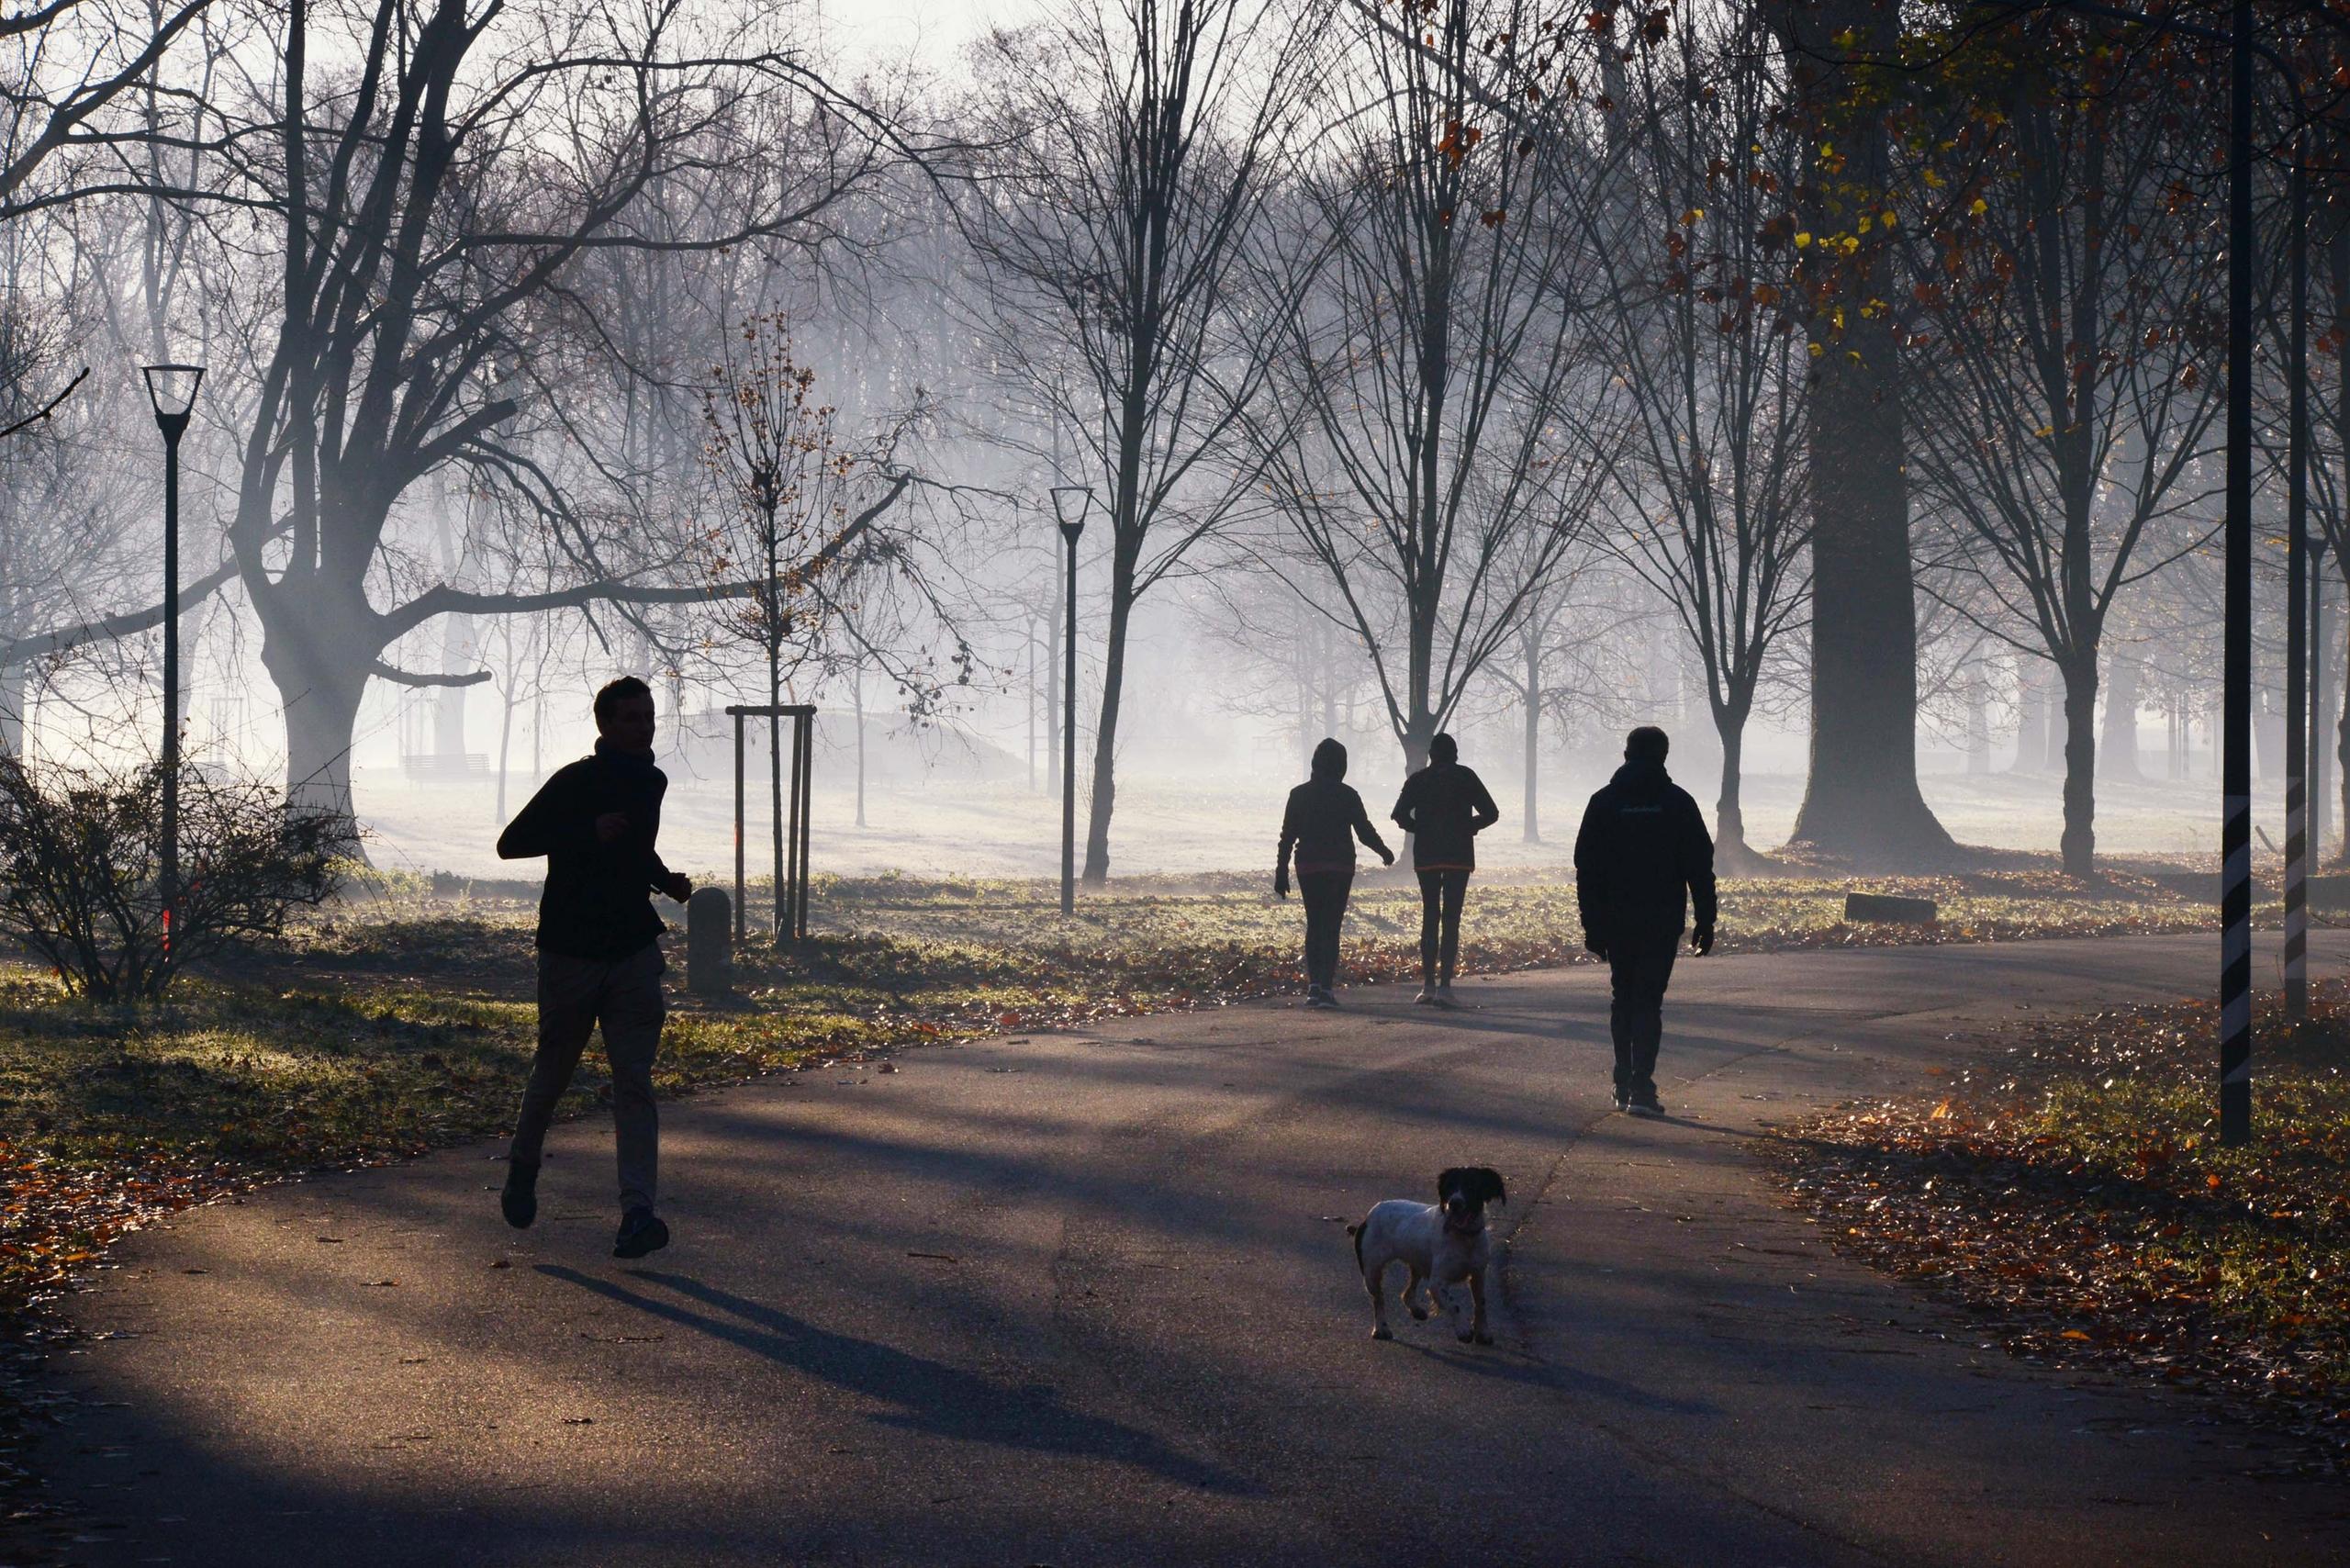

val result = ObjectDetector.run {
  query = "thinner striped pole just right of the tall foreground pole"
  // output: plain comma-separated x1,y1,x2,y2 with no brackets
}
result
2284,150,2310,1018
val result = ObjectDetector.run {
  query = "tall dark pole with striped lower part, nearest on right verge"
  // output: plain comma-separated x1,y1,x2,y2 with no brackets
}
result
2219,0,2251,1145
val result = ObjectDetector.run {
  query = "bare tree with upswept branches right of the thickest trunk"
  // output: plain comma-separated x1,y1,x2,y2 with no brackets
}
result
1913,17,2221,877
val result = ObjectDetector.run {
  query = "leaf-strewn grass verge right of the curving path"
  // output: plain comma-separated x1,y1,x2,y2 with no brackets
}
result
1755,985,2350,1474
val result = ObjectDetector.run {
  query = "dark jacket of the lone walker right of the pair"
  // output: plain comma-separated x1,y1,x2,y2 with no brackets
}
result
1574,762,1713,947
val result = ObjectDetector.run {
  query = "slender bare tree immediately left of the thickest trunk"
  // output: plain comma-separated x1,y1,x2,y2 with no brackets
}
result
1598,12,1812,860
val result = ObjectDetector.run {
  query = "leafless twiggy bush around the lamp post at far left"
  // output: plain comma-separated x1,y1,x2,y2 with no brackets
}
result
0,757,352,1002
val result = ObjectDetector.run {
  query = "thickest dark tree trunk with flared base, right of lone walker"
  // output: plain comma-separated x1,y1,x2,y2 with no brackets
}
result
1781,0,1955,868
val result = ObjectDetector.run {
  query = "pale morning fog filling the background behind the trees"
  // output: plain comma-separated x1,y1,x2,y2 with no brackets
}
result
0,0,2312,877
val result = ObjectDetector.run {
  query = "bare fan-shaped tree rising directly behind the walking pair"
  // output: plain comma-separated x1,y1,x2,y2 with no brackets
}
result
1250,0,1612,767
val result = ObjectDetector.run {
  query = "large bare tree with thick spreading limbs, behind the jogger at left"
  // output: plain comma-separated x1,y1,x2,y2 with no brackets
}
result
153,0,934,832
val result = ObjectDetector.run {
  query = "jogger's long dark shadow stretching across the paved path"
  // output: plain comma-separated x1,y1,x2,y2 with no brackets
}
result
536,1262,1252,1495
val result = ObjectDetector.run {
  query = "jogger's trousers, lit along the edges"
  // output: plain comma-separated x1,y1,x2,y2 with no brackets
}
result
510,943,667,1213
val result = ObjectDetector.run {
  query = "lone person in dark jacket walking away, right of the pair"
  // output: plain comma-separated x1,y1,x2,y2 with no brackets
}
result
1574,724,1713,1116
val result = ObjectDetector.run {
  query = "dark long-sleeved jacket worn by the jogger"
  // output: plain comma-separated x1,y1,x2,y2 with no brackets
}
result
498,741,670,964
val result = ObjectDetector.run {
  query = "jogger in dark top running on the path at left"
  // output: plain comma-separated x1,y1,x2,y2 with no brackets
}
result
498,675,693,1258
